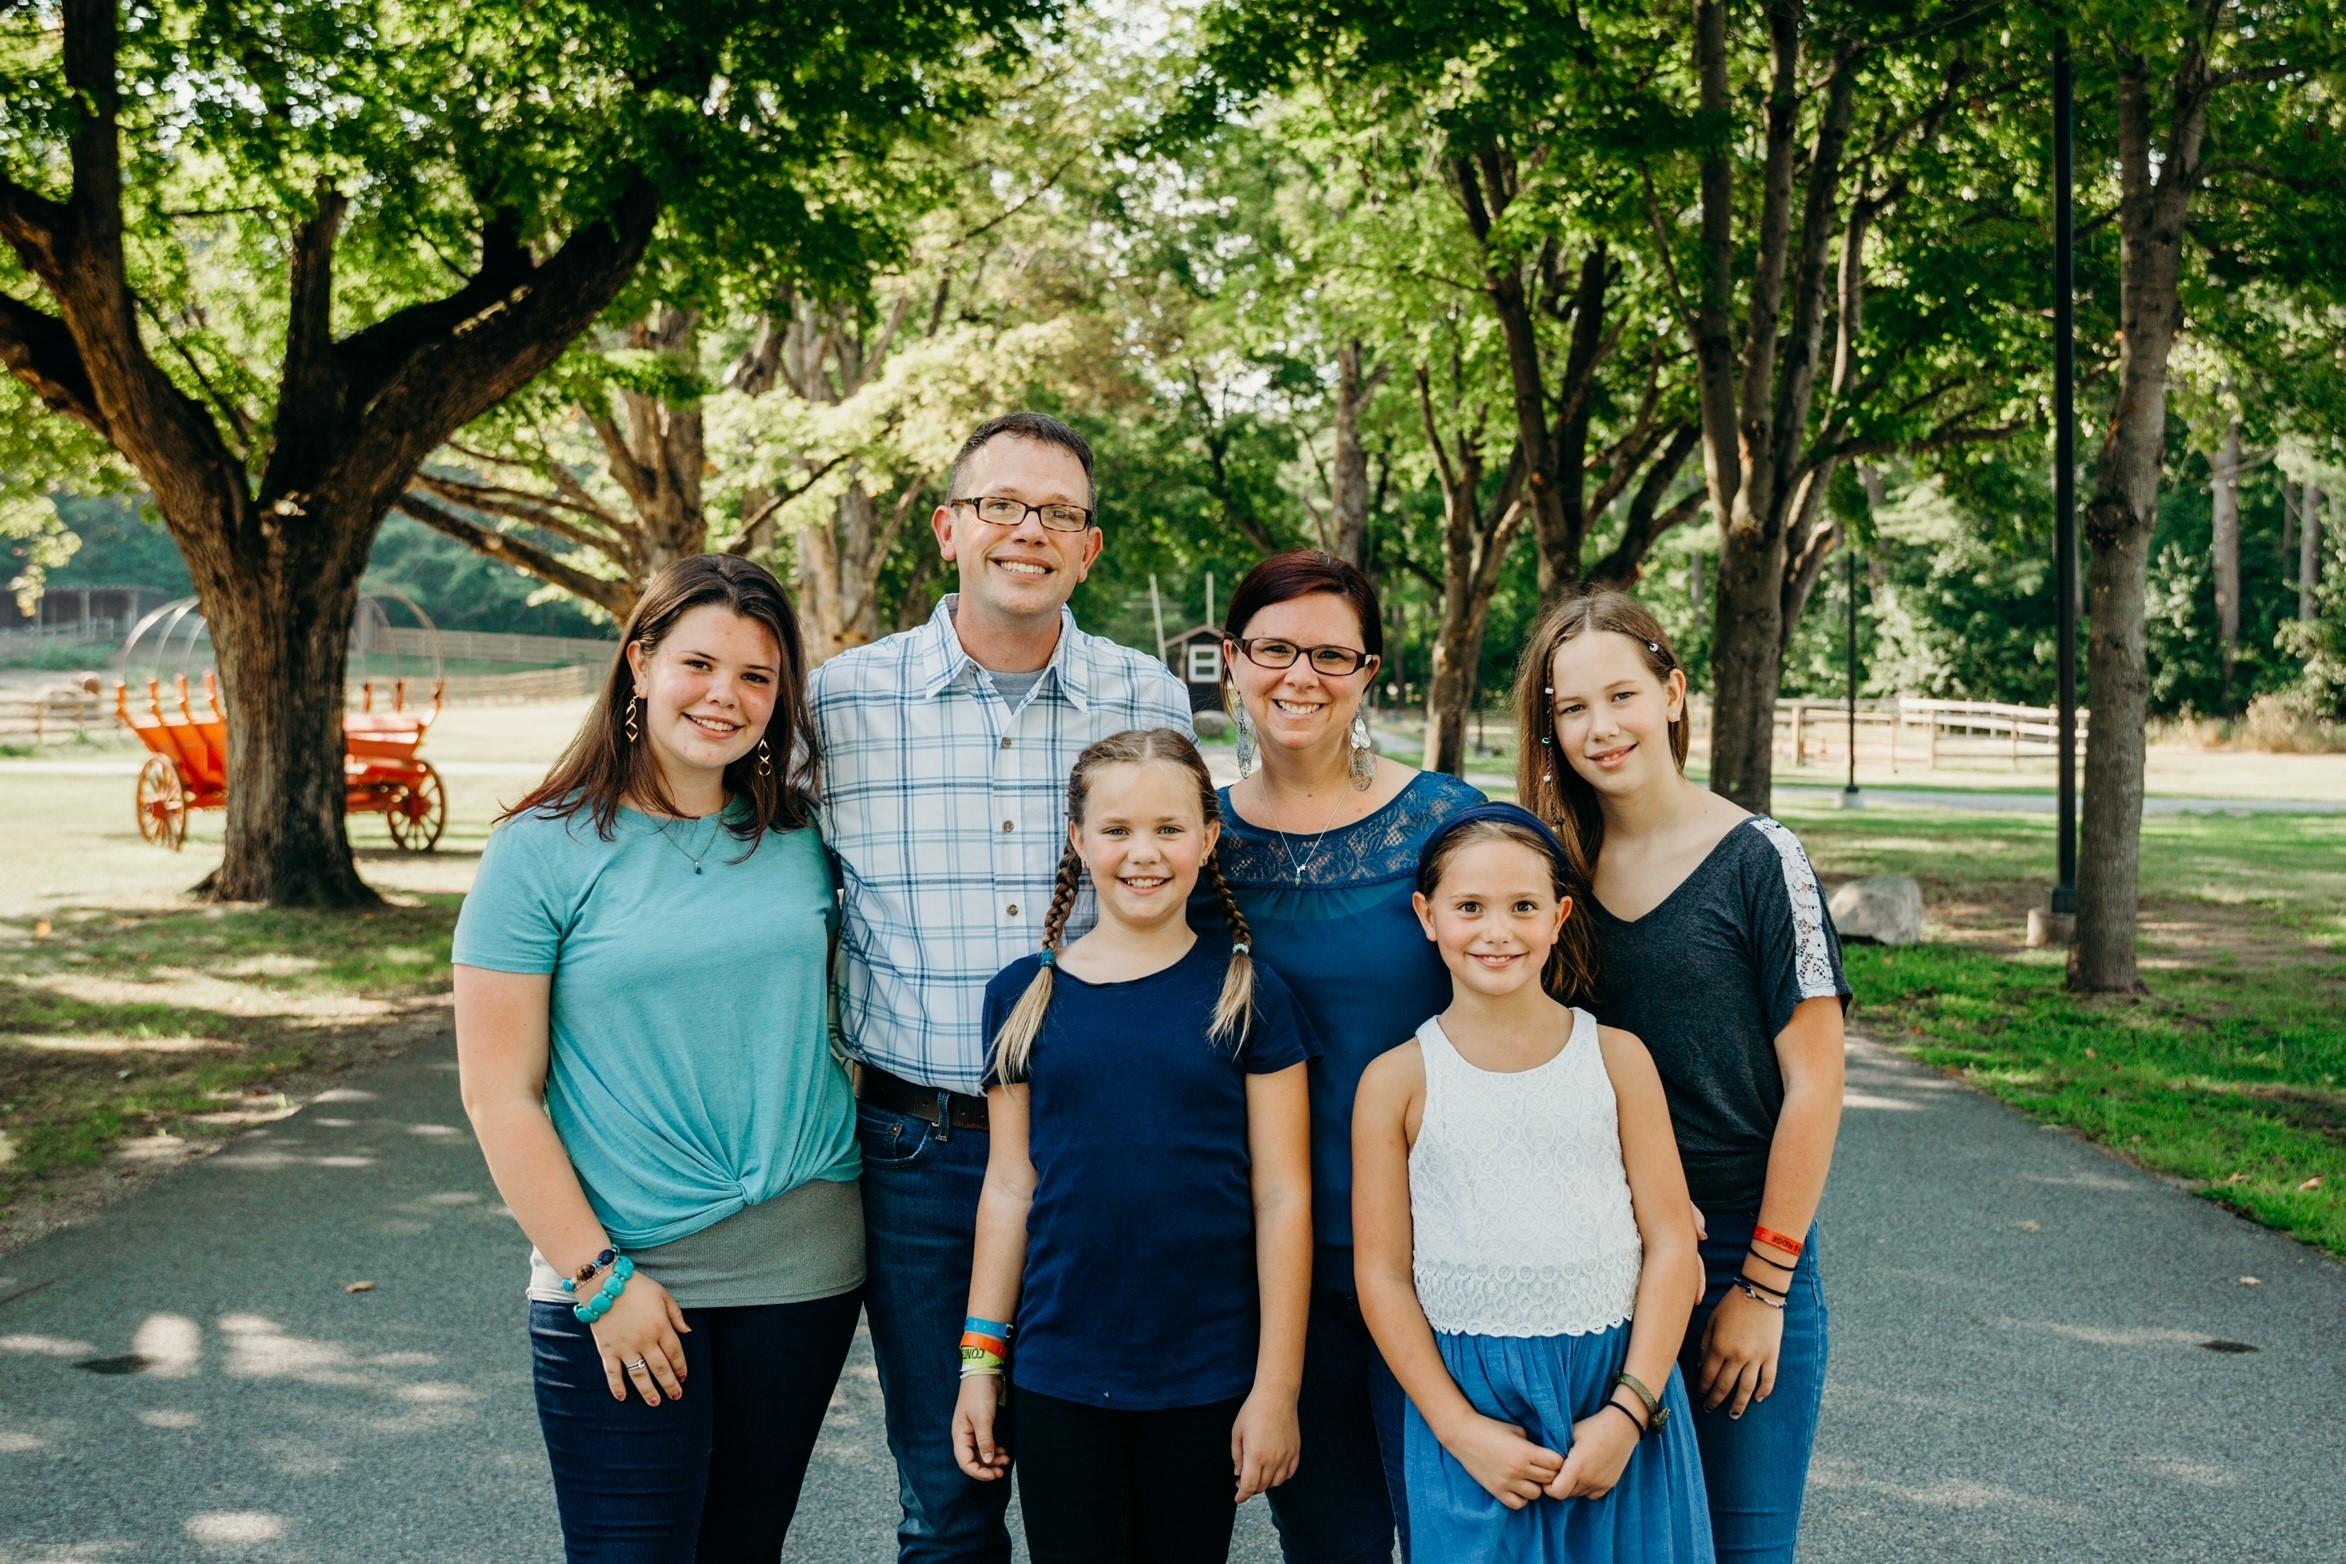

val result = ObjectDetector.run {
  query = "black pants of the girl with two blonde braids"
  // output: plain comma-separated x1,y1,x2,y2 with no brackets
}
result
1011,1390,1246,1564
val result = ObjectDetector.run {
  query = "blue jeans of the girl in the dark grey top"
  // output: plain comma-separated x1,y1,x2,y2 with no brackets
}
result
1677,1215,1825,1564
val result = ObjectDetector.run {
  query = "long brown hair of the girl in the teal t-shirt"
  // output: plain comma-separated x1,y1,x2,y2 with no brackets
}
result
497,553,819,858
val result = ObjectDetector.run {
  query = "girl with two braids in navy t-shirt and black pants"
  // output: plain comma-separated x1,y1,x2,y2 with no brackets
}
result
952,727,1318,1564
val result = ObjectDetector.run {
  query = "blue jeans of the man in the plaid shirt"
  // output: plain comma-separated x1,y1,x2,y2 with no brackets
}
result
856,1102,1016,1564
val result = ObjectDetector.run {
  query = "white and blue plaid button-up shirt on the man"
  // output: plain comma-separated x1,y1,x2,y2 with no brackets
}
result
807,593,1192,1093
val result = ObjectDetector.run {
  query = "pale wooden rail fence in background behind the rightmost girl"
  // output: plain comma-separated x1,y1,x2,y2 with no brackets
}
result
1694,694,2090,771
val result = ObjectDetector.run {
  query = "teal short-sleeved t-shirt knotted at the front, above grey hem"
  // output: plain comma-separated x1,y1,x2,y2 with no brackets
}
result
455,809,861,1250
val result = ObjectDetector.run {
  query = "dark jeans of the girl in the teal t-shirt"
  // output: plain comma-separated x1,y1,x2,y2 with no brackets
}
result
530,1292,861,1564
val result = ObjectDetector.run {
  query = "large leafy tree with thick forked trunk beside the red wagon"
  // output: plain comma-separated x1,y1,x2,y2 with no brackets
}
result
0,0,1032,905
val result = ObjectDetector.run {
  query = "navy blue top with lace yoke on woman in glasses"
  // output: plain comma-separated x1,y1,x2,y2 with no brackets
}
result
1192,771,1483,1292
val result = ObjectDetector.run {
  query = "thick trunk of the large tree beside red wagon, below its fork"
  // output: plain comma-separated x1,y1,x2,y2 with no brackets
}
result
176,516,380,907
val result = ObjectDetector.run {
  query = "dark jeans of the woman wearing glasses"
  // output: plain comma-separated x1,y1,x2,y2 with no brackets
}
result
1272,1292,1410,1564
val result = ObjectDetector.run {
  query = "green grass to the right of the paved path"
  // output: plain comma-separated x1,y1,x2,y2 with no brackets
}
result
1792,811,2346,1257
